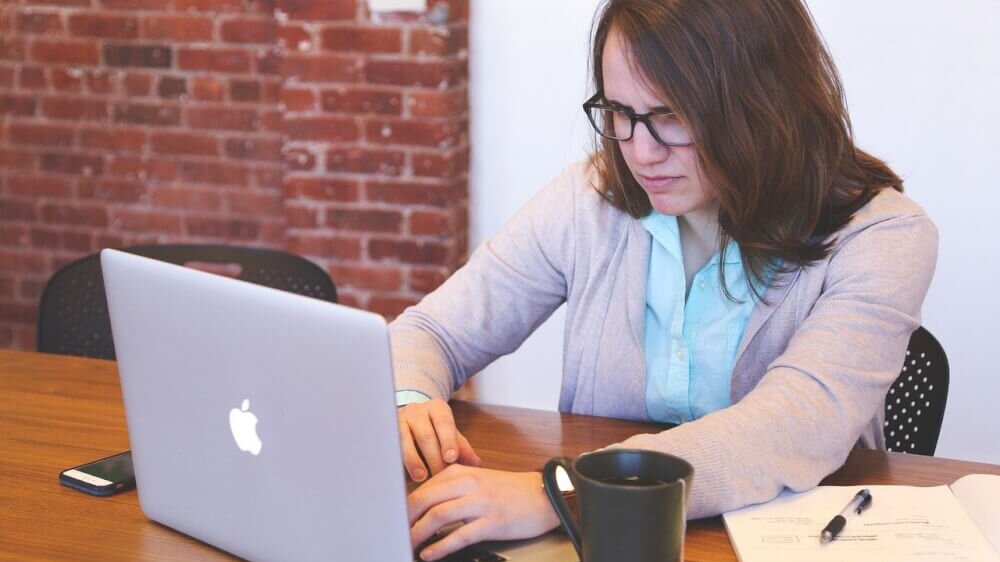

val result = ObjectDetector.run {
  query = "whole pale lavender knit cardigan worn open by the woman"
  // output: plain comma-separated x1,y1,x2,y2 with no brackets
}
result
390,163,937,518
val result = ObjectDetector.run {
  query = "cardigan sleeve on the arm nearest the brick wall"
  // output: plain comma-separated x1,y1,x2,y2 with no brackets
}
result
389,166,584,399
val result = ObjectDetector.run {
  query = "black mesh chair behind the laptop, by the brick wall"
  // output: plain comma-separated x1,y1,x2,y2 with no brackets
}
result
36,244,337,359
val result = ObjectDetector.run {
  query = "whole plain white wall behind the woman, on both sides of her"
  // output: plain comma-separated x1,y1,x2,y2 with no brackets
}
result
470,0,1000,463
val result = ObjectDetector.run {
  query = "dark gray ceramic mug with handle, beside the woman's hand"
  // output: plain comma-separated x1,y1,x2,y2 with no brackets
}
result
542,449,694,562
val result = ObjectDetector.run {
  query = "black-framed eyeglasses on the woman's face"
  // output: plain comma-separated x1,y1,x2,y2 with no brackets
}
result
583,90,694,147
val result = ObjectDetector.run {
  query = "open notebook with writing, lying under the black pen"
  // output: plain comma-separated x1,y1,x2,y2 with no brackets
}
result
723,474,1000,562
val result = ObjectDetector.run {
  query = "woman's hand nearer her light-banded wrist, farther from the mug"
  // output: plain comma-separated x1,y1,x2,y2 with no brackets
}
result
399,398,483,482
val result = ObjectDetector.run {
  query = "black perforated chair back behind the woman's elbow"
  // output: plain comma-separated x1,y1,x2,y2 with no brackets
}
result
882,327,948,456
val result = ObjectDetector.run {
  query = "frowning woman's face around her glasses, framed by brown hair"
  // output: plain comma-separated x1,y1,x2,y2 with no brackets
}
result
602,32,716,218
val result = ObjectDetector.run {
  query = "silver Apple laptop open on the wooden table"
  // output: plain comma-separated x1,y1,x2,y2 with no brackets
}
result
101,250,576,562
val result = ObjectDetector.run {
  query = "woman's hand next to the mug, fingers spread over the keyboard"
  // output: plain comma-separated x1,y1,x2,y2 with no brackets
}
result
407,465,559,560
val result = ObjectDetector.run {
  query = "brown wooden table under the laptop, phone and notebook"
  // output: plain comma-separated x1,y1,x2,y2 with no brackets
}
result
0,350,1000,562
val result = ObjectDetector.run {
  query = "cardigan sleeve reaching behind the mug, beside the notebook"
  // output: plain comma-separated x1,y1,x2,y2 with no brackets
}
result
614,208,937,518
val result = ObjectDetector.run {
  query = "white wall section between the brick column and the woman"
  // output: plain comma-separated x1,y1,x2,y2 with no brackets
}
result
467,0,597,410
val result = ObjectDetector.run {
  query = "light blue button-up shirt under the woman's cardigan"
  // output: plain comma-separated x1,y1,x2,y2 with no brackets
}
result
642,211,756,423
